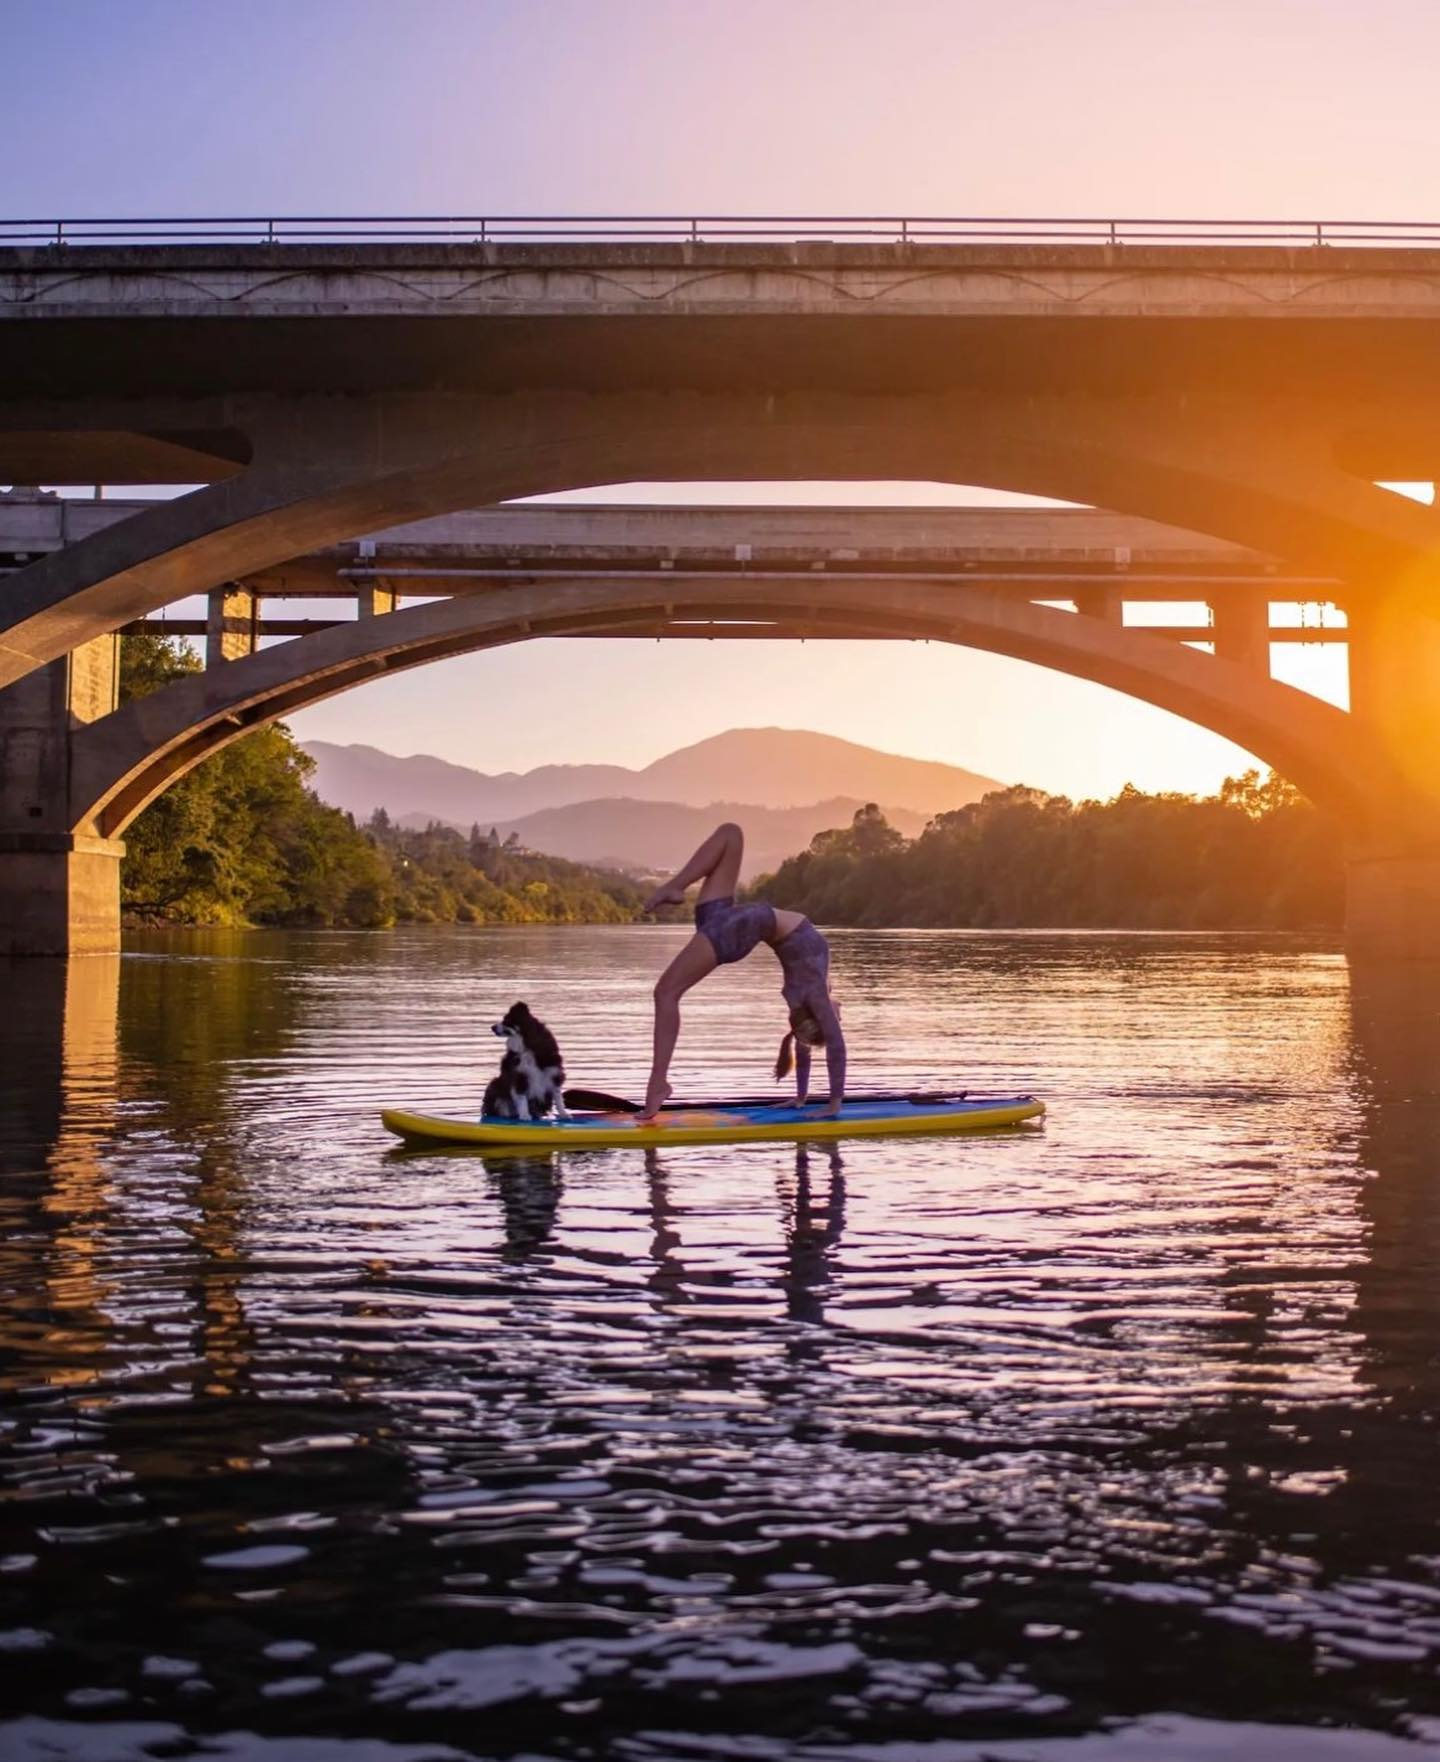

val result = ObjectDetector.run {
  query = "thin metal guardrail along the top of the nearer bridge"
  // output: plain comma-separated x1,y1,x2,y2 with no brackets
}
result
0,215,1440,248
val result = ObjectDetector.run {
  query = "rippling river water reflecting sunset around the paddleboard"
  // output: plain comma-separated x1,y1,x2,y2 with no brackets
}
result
0,927,1440,1762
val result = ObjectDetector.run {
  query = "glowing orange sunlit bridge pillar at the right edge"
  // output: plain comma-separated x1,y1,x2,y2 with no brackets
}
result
1345,590,1440,960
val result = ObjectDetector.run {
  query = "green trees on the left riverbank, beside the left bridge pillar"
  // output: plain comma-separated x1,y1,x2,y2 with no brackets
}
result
120,633,642,929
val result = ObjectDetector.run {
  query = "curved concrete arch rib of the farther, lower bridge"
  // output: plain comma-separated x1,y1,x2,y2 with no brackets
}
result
69,578,1382,839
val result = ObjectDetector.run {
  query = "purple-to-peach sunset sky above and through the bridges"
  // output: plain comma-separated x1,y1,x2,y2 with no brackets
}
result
0,0,1440,795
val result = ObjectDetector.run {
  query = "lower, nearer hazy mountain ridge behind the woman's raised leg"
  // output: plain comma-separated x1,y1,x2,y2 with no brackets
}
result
400,796,927,879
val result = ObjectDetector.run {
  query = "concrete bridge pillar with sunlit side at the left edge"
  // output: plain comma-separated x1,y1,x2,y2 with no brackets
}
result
0,636,125,955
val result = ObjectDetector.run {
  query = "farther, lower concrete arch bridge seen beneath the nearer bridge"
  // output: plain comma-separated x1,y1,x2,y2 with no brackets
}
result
0,497,1395,948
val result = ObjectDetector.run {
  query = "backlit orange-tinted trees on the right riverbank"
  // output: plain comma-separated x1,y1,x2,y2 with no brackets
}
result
754,772,1343,930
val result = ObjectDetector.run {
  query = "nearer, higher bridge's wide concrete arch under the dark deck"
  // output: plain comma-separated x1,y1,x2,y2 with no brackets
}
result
0,391,1436,685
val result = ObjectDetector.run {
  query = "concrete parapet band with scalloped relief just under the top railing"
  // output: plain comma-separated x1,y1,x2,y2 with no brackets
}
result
0,240,1440,331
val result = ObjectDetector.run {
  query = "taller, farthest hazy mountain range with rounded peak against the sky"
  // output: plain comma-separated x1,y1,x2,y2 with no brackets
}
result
305,728,1001,828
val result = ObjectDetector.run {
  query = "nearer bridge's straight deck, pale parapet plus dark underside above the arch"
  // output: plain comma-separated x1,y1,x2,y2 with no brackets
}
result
0,240,1440,422
